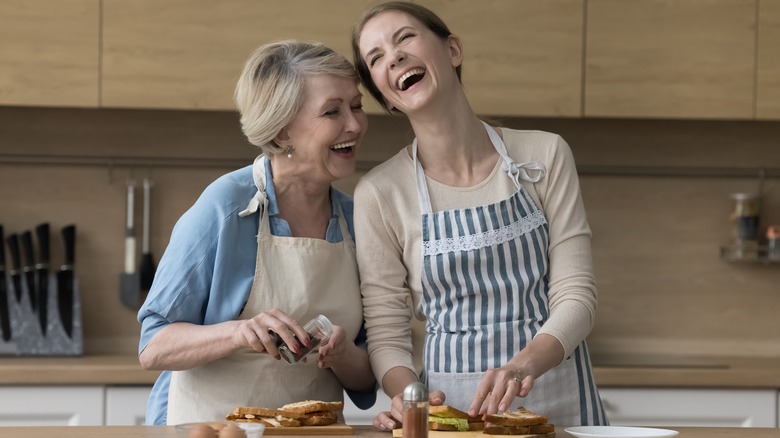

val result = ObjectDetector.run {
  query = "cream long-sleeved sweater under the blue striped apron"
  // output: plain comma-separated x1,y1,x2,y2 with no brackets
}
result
355,128,597,382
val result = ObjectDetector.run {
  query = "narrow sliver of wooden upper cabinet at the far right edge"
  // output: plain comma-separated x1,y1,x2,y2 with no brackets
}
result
756,1,780,120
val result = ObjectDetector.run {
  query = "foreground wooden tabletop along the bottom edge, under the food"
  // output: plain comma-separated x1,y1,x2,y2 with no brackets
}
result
0,426,778,438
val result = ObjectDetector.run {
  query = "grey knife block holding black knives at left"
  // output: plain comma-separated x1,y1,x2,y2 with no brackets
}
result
0,275,84,356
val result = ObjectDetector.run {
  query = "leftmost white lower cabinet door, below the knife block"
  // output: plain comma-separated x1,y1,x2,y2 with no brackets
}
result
0,386,103,426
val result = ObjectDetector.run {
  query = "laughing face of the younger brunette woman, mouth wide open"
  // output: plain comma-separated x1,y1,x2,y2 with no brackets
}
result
358,10,462,114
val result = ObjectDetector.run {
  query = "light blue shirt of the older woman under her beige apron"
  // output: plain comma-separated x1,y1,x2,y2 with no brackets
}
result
138,160,376,425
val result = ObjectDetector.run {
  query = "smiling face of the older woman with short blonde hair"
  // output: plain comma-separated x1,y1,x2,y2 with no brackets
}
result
274,74,368,184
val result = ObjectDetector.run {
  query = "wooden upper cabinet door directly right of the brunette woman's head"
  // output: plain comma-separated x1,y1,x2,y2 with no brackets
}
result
418,0,584,117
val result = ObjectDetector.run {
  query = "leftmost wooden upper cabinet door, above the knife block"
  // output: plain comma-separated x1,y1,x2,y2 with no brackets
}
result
0,0,100,107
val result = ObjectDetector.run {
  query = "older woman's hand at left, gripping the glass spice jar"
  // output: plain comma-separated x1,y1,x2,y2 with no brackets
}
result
233,309,311,360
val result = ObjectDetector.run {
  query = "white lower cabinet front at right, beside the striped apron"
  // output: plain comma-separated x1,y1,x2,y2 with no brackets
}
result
599,388,780,427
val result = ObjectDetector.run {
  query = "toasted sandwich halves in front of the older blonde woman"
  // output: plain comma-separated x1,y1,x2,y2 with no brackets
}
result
225,400,344,427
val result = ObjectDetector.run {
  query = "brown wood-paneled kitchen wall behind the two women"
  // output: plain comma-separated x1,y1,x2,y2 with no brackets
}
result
0,107,780,356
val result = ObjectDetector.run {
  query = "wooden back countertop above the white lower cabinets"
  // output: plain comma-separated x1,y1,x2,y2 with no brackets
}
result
0,355,780,388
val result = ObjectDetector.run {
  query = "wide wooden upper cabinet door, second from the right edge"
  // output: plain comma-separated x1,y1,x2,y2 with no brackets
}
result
584,0,756,119
